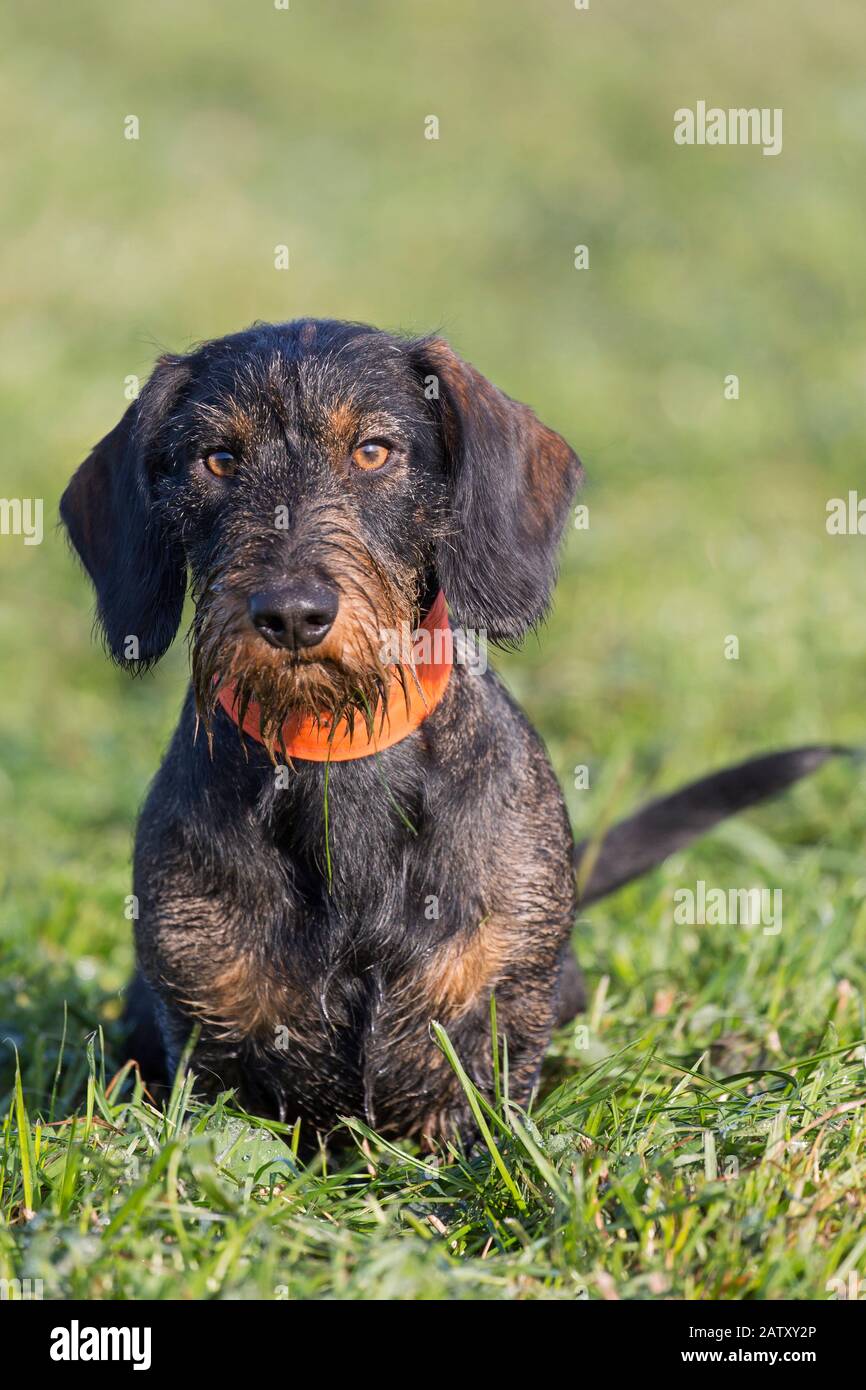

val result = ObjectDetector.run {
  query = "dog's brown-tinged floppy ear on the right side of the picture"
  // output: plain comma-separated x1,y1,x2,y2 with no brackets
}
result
413,338,582,642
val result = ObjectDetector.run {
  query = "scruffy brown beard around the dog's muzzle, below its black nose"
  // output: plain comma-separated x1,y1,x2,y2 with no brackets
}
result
190,564,418,756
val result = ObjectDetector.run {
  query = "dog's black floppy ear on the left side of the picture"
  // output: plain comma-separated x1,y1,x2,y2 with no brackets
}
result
60,357,189,670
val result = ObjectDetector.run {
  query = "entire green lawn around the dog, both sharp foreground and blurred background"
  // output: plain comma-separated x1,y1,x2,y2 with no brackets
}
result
0,0,866,1300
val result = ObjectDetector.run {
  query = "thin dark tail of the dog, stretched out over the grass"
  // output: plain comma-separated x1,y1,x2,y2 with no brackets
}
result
574,744,858,906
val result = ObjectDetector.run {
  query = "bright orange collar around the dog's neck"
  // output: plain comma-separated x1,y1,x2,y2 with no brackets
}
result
218,589,453,763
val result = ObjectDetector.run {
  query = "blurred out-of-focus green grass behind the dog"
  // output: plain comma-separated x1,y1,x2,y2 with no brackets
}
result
0,0,866,1290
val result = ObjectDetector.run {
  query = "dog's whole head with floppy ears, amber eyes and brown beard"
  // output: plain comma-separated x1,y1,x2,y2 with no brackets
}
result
60,321,580,728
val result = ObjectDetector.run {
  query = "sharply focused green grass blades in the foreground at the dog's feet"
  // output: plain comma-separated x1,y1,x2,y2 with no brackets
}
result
0,990,866,1300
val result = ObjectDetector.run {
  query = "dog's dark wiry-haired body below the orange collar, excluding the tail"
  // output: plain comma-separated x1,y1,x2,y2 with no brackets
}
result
135,669,574,1134
